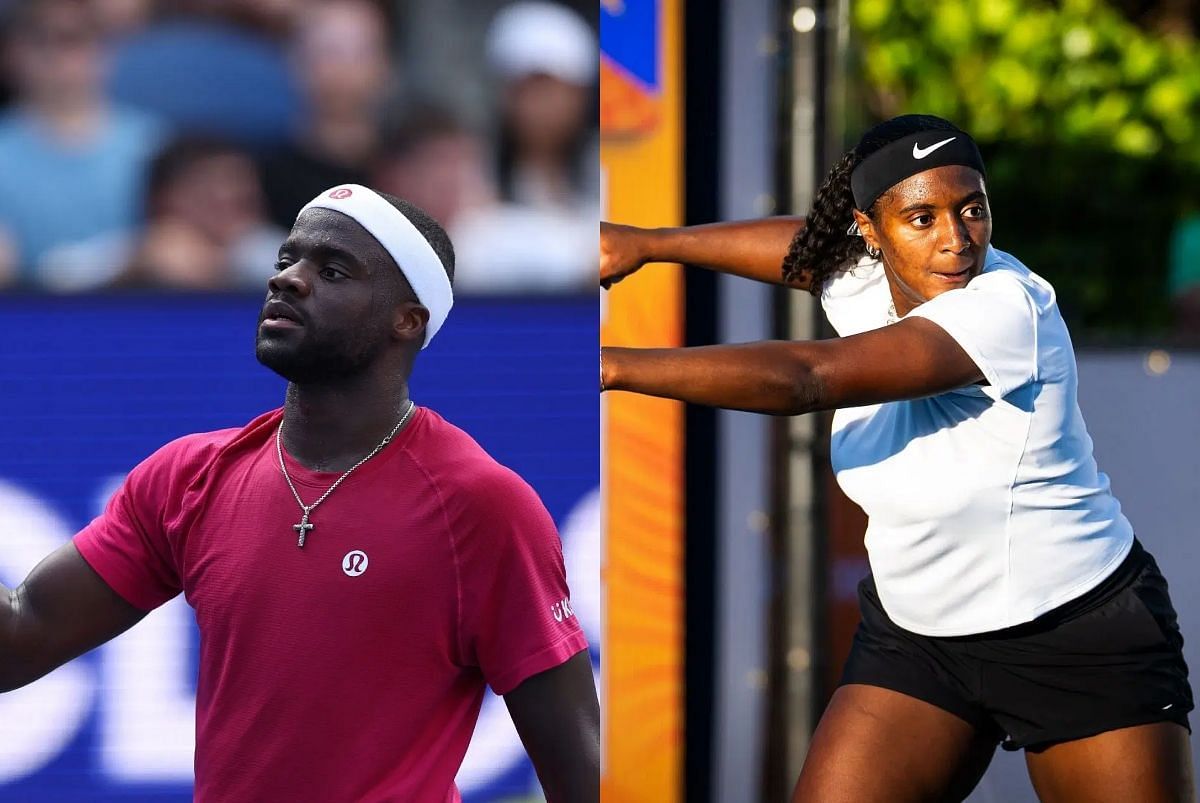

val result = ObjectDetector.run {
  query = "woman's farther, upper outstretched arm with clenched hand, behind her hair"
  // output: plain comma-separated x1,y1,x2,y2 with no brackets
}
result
600,217,809,290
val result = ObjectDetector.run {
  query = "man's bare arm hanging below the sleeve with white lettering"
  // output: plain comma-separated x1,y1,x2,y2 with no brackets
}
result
504,649,600,803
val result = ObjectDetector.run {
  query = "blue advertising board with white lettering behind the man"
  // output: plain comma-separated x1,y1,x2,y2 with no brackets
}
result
0,294,601,803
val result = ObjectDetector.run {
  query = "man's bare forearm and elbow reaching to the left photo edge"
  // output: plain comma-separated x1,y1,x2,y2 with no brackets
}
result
0,544,146,691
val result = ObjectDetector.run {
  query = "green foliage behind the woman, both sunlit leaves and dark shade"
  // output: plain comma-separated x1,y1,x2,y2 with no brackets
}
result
852,0,1200,335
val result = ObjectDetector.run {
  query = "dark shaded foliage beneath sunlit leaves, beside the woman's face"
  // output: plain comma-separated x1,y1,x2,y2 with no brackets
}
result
983,143,1200,333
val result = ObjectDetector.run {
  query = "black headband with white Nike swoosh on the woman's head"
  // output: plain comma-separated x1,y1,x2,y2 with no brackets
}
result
850,130,984,211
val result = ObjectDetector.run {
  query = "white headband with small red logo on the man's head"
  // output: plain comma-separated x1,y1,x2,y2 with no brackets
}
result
296,184,454,348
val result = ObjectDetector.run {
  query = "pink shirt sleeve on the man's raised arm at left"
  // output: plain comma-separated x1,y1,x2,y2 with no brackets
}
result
74,441,189,611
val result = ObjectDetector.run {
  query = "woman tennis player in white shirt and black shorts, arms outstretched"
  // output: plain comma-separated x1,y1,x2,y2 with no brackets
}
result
600,115,1194,803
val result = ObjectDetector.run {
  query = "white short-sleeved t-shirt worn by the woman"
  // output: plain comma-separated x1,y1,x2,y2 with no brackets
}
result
821,247,1133,636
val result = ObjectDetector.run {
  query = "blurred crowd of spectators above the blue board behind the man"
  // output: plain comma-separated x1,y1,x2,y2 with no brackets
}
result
0,0,600,294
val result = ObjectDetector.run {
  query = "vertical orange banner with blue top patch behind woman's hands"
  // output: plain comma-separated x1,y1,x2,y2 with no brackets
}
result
600,0,684,803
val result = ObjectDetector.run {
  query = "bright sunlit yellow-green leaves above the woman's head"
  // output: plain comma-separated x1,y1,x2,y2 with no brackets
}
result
852,0,1200,158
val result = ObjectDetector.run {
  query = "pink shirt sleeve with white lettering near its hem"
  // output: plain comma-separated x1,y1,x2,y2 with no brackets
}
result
457,468,588,695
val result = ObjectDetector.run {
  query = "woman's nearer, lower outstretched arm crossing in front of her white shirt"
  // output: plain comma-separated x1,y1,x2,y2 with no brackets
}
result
600,318,984,415
